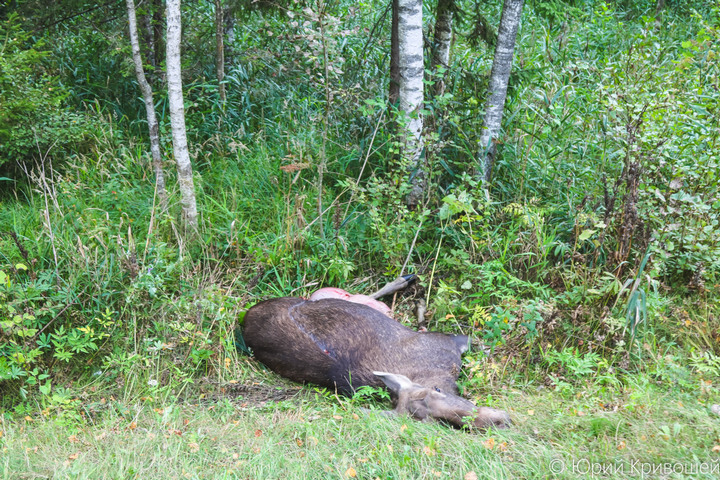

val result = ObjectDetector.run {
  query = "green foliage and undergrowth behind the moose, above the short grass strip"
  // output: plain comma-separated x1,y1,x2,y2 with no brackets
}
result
0,0,720,420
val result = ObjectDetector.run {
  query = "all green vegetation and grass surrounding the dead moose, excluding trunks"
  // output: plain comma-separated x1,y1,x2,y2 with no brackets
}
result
0,0,720,479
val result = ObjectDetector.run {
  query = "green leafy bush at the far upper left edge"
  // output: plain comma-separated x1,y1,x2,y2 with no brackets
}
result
0,14,93,171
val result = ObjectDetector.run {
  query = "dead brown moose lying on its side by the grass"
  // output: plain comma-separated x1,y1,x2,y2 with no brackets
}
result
243,289,510,428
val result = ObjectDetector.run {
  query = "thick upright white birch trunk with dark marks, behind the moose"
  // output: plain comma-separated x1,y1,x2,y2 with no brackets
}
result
398,0,426,207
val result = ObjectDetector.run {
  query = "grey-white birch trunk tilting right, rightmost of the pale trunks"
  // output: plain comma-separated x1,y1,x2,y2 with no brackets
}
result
478,0,523,183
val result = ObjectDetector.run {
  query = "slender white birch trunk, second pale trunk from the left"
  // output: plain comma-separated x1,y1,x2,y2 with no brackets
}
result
165,0,198,232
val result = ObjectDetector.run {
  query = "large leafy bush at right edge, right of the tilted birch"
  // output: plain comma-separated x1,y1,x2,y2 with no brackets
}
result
506,3,718,292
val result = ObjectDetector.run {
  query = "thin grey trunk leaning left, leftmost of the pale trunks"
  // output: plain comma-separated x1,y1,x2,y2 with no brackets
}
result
126,0,167,211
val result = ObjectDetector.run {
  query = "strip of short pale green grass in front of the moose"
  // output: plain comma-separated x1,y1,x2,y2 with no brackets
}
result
0,366,720,479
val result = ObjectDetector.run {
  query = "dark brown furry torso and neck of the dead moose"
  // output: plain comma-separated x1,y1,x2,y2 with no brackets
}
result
243,297,467,393
